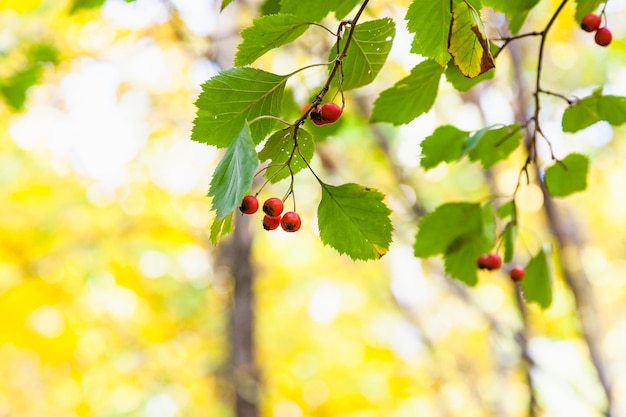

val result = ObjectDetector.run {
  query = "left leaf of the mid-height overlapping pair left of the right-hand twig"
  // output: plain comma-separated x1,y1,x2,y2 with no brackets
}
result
420,125,469,169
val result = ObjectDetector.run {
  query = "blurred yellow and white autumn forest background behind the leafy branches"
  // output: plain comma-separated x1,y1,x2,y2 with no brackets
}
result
0,0,626,417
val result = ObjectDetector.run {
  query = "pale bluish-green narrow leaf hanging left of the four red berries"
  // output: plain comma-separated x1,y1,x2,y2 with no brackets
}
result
209,123,259,219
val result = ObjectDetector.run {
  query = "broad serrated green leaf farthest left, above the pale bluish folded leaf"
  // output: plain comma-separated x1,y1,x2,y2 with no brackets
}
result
191,68,288,148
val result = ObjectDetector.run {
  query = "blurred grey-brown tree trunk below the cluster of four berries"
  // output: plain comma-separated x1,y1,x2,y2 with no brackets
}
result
221,213,259,417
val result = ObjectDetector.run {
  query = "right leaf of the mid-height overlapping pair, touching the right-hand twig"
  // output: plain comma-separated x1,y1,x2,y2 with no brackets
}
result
469,124,522,168
